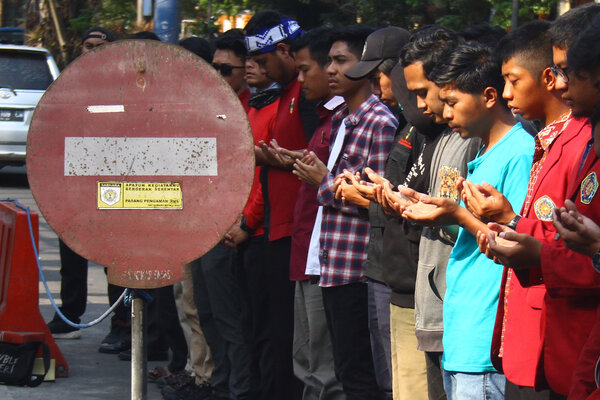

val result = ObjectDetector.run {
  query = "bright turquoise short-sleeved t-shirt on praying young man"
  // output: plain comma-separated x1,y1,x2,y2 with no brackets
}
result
442,123,535,373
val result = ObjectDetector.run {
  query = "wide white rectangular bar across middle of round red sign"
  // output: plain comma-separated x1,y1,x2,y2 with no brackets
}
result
65,137,217,176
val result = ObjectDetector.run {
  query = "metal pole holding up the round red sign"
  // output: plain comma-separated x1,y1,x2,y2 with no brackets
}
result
131,292,148,400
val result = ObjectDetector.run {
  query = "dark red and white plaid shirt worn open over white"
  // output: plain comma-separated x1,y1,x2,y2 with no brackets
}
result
317,95,398,287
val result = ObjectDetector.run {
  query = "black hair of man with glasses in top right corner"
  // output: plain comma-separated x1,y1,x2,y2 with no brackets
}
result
548,2,600,49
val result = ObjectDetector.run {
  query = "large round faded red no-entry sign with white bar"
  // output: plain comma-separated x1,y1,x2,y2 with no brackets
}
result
27,40,254,288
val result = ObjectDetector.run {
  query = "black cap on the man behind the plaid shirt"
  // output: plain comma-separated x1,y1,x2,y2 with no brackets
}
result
345,26,410,80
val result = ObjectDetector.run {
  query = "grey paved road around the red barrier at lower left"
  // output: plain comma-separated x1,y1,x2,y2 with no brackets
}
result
0,167,161,400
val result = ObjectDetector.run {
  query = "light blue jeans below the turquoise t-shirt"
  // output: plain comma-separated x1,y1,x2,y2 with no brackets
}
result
443,370,506,400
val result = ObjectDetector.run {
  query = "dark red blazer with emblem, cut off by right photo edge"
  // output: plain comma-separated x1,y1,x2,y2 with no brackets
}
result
542,146,600,394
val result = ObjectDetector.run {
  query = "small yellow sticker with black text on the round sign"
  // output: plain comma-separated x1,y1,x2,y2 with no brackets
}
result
98,182,183,210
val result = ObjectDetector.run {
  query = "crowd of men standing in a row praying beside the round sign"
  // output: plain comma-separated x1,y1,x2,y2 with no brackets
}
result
48,3,600,400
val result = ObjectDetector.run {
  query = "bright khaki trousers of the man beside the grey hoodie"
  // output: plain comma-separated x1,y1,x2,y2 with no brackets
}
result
390,304,428,400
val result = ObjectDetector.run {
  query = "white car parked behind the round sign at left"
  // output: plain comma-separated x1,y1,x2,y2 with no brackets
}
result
0,45,59,168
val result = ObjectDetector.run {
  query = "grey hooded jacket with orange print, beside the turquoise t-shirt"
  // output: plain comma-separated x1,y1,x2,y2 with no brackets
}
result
415,130,481,352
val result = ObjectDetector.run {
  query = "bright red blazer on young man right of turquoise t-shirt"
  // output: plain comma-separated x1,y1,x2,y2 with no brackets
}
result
491,118,591,394
